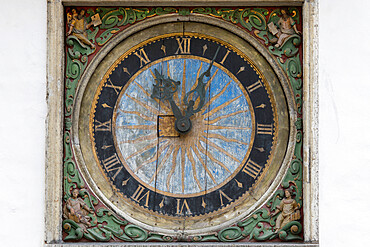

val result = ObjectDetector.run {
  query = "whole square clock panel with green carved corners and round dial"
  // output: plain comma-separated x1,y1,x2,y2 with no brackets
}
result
63,7,303,242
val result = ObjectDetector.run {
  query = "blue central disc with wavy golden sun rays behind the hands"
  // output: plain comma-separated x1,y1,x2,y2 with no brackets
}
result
114,56,254,196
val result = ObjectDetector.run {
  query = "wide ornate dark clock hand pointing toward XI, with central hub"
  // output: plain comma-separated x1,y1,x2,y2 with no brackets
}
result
151,69,192,134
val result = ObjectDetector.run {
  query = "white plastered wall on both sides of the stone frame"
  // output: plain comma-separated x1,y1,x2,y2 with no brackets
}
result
0,0,370,247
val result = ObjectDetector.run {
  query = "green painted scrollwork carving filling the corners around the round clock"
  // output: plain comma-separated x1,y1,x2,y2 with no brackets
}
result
63,7,303,242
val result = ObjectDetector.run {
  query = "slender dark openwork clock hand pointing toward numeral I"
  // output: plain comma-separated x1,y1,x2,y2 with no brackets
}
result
183,47,220,117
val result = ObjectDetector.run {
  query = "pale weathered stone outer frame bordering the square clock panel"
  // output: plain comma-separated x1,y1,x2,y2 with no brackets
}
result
44,0,319,247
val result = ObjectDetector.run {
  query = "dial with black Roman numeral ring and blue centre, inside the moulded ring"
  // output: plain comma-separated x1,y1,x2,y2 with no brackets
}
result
90,34,277,217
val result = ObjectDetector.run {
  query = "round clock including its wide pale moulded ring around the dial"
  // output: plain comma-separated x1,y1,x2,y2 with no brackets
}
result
75,22,290,234
